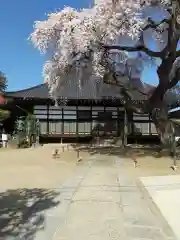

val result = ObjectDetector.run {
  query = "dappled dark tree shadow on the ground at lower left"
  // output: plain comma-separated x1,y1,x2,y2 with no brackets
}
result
0,188,59,240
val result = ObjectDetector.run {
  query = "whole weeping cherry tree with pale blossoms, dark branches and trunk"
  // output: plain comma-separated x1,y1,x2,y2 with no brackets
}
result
30,0,180,148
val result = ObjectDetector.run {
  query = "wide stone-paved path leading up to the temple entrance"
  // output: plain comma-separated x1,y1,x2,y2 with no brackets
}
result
33,155,176,240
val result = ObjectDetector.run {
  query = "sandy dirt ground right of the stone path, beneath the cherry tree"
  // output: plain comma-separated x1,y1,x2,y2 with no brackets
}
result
75,143,180,177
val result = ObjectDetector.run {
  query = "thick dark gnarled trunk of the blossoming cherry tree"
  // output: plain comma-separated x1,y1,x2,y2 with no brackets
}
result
109,54,175,158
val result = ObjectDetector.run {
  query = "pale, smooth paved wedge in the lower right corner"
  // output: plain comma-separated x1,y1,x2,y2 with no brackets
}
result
141,175,180,239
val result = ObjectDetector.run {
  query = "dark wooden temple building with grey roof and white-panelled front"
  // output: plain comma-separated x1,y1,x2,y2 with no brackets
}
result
0,80,157,141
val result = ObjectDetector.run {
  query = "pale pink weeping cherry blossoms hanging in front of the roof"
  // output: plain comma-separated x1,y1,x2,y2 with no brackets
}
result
30,0,167,98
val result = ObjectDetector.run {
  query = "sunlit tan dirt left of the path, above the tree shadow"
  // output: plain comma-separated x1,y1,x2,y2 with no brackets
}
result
0,144,89,191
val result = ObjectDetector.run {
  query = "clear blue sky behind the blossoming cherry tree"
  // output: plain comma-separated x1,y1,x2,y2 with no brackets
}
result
0,0,162,91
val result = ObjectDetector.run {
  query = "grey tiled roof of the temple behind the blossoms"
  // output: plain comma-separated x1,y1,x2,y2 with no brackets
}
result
5,80,153,100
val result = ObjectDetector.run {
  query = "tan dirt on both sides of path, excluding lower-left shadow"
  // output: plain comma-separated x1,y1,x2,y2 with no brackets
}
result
0,144,180,191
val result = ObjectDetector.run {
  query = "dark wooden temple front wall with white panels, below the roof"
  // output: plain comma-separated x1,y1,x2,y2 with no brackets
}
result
1,99,156,137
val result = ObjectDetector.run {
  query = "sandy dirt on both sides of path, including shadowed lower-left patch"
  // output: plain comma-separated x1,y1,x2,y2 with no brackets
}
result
0,144,180,239
